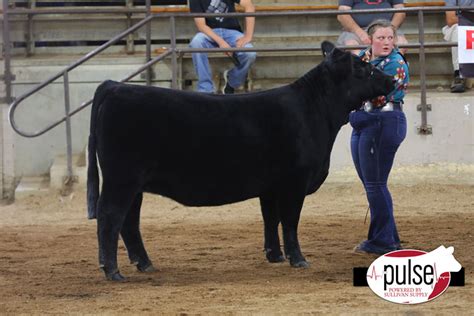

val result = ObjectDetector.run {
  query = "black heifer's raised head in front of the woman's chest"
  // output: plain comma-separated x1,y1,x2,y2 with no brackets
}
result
321,41,394,111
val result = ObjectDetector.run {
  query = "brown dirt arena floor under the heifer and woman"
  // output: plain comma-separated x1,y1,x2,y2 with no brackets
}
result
0,183,474,315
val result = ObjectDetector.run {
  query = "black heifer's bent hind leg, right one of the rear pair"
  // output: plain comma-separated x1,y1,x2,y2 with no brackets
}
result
120,193,155,272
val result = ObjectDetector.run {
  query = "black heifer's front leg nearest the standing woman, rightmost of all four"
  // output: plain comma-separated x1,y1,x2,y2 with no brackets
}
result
279,194,309,268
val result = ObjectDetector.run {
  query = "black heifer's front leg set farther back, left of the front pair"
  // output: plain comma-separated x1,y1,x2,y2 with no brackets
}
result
260,197,285,262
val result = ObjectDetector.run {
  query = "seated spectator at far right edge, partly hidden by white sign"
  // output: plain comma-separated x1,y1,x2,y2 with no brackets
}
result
443,0,474,93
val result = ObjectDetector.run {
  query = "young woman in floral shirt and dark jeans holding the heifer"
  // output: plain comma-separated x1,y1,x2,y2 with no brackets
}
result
350,20,409,254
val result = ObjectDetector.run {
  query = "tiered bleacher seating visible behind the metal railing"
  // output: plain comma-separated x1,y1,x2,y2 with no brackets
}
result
1,0,452,89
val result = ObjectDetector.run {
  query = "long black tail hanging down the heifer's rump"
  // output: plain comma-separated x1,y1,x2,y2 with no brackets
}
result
87,81,113,219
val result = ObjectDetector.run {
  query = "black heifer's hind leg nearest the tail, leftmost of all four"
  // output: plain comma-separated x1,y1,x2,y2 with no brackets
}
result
97,182,136,281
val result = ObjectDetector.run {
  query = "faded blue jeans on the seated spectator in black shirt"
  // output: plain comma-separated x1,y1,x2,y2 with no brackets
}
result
189,28,257,93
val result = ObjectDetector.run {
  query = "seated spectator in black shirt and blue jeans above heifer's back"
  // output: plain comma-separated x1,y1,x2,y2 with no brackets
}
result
189,0,256,94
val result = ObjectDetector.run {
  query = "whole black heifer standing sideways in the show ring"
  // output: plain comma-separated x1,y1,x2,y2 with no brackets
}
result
87,42,393,280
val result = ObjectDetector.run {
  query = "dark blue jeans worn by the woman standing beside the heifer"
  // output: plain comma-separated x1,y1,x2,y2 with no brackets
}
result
349,110,407,253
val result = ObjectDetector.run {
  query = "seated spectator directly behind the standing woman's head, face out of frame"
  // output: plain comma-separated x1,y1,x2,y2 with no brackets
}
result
337,0,407,55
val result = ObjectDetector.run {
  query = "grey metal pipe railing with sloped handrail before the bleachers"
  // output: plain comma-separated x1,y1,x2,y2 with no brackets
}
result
3,0,469,183
